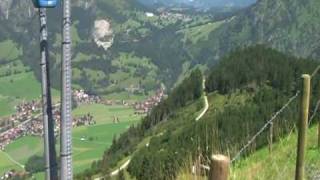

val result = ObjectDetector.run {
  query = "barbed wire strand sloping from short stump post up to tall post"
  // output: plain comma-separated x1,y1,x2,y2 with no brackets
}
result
231,91,301,163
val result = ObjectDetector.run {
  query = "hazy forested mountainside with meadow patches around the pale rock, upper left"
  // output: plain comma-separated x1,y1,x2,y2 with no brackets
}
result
0,0,212,95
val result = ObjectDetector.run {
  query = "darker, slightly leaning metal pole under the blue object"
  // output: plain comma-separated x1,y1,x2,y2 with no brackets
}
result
39,8,58,180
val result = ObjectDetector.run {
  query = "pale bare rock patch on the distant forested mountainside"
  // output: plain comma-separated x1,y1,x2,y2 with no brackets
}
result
93,19,114,50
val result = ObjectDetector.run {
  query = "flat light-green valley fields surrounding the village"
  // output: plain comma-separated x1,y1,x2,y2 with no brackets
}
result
0,104,141,177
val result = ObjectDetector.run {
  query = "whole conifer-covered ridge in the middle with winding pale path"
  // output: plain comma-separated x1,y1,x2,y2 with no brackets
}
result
77,45,319,180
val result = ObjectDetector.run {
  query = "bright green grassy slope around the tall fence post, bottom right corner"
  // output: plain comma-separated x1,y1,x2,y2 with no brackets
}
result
231,127,320,180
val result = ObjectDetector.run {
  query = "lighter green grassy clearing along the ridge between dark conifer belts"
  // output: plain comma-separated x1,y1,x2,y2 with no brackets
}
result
99,93,249,179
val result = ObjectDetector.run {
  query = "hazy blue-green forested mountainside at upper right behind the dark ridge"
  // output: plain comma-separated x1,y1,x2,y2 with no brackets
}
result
187,0,320,66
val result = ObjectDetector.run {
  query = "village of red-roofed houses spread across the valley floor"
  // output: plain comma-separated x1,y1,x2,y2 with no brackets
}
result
0,87,166,150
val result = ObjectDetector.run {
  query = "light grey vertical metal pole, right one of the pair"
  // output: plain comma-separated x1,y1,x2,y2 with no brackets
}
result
60,0,73,180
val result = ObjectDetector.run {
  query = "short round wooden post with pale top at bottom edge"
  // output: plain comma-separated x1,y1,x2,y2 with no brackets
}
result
209,154,230,180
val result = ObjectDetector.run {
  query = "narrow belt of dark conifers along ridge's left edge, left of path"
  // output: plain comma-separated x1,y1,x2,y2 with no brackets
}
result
77,69,203,178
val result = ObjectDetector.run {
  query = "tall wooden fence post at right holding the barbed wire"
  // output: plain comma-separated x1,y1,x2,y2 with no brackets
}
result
295,74,311,180
